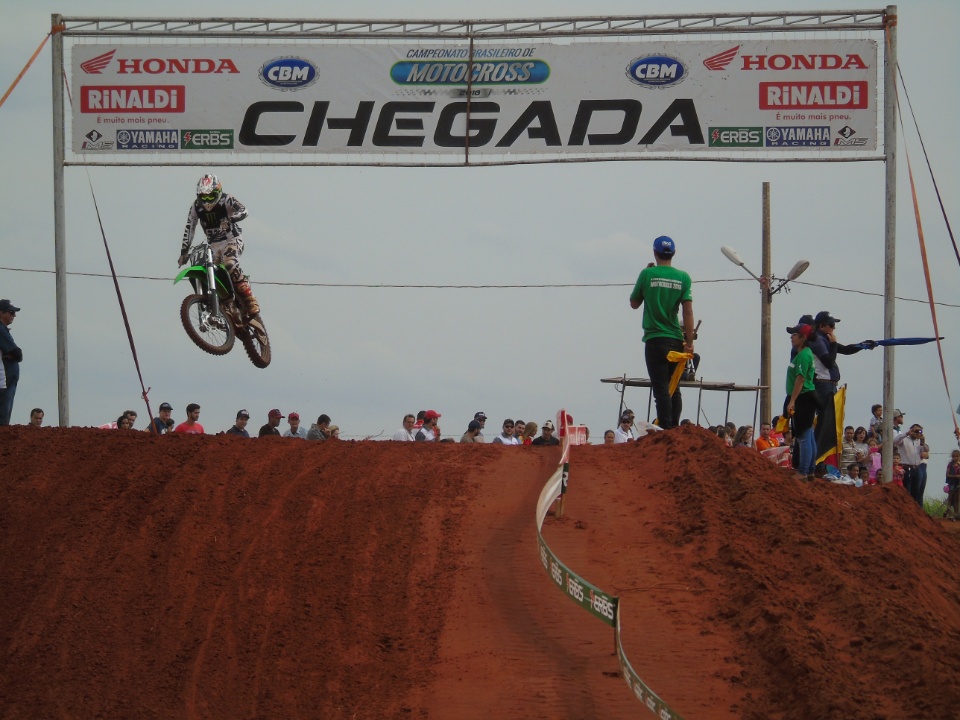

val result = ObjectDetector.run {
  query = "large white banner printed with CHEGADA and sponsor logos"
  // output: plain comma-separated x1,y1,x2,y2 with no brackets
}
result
72,40,878,158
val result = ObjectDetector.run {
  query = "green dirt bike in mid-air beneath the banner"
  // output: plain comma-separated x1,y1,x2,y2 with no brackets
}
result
173,243,270,368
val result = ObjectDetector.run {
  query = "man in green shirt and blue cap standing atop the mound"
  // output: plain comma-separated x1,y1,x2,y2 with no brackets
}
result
630,235,693,430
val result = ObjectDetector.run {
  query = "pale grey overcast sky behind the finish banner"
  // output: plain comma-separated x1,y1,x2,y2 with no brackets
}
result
0,0,960,470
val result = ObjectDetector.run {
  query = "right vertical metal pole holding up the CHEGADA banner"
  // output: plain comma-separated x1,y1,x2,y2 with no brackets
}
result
882,5,897,483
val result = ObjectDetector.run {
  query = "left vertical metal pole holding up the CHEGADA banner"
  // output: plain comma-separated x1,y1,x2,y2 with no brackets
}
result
50,13,70,427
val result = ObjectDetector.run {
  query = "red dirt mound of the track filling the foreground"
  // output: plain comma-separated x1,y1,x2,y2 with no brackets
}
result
0,427,960,720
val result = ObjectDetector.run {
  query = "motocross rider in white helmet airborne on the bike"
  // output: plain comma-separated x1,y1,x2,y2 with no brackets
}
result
179,174,260,317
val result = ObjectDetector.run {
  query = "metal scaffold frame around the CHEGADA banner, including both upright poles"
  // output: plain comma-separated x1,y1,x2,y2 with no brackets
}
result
51,5,897,490
